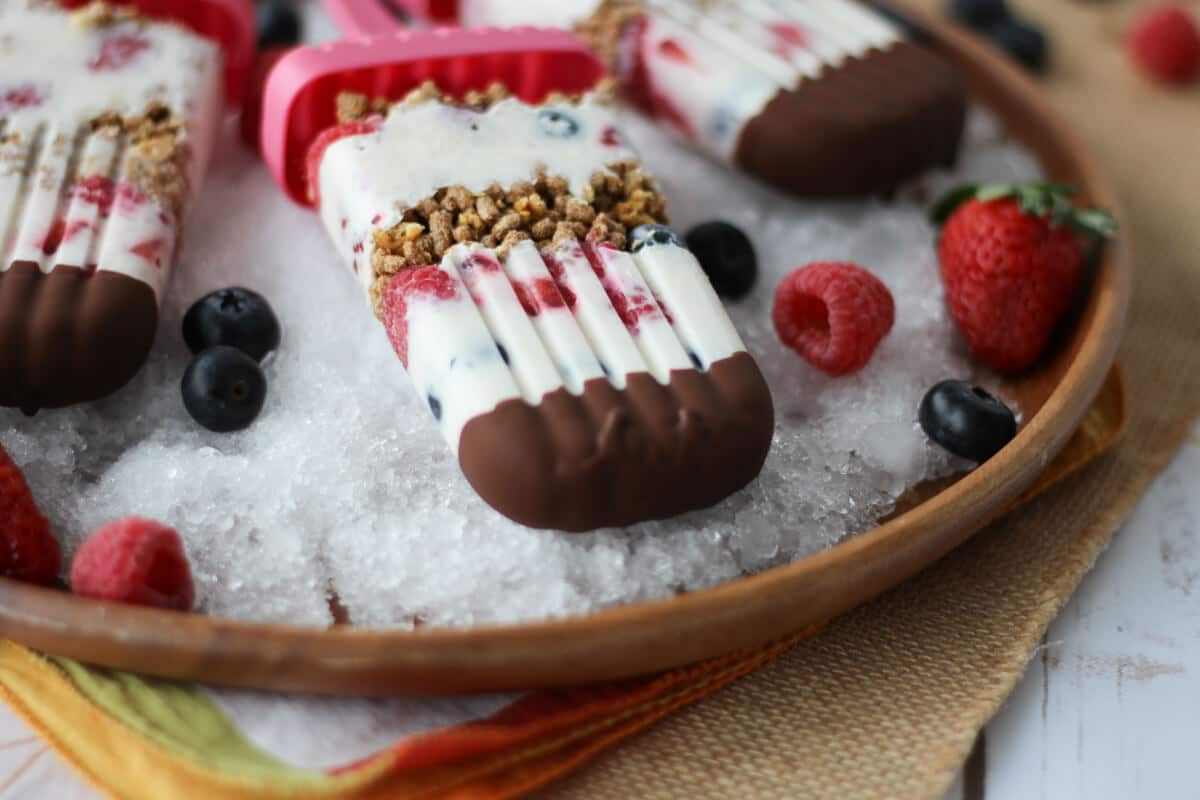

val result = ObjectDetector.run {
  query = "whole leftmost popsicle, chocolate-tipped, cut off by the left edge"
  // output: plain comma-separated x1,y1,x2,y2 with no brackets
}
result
0,0,253,411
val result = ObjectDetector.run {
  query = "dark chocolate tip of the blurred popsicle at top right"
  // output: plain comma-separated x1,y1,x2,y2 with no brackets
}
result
734,42,967,197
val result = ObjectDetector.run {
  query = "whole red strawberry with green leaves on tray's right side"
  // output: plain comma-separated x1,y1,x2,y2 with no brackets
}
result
934,181,1117,373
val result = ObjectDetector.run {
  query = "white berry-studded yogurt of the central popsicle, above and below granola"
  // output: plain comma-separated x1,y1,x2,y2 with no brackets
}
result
316,89,744,449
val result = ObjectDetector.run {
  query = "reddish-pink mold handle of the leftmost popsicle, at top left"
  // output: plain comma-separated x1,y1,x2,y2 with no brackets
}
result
59,0,256,107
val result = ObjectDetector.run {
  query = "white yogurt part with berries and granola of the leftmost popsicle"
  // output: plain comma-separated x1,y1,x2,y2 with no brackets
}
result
0,0,222,297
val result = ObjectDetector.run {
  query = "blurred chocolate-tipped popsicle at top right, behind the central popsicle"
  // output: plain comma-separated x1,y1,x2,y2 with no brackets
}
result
325,0,966,197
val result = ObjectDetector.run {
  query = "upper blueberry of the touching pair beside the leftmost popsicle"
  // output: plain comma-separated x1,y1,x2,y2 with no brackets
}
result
184,287,280,361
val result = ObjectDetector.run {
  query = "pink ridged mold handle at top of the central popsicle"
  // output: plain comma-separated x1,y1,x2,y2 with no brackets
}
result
262,28,605,205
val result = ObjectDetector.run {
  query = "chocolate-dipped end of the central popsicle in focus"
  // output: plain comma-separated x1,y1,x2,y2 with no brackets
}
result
458,353,775,531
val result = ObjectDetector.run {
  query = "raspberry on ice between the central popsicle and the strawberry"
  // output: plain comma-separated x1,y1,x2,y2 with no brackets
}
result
772,263,895,378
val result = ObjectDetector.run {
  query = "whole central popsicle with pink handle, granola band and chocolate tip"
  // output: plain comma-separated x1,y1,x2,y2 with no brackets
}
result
263,29,774,531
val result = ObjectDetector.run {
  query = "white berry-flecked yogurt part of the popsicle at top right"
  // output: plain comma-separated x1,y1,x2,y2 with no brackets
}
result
451,0,904,161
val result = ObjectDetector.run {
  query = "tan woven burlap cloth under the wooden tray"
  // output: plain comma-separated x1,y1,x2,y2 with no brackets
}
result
548,0,1200,800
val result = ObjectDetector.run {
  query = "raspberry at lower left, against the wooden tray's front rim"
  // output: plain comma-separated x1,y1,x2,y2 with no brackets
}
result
71,517,194,612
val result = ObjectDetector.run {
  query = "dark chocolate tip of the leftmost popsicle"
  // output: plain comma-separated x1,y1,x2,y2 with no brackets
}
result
0,261,158,411
